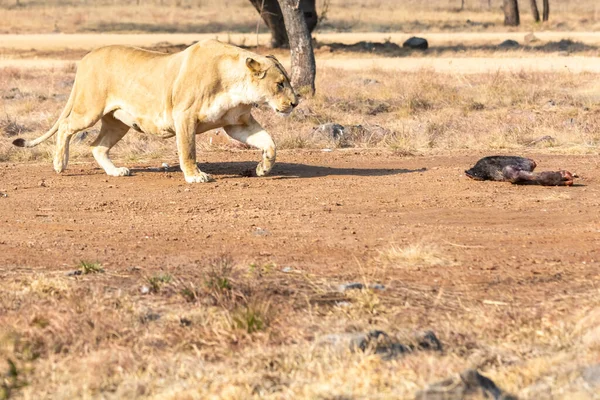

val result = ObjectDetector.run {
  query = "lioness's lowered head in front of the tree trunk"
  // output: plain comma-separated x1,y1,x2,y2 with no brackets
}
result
246,56,298,114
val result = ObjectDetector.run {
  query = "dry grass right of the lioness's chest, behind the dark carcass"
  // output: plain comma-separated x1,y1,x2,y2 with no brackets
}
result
258,70,600,154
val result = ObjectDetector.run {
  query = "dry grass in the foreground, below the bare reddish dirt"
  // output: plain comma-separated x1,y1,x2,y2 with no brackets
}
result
0,252,600,399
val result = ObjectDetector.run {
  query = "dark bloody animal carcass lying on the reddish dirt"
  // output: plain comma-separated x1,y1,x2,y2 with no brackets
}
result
465,156,573,186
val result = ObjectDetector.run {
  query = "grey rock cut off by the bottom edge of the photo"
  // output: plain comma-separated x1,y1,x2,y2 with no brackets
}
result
415,369,516,400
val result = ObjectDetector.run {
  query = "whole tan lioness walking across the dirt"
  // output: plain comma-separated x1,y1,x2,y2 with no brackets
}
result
13,40,298,183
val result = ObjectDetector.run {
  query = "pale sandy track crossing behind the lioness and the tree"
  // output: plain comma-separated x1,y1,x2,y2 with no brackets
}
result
0,32,600,74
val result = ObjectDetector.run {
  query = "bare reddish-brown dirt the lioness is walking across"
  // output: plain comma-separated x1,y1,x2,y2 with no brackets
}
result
0,150,600,294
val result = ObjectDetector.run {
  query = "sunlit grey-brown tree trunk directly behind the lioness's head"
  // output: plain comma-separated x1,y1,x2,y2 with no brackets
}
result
278,0,316,96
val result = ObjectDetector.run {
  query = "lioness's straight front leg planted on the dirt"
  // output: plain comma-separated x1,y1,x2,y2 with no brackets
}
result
175,114,214,183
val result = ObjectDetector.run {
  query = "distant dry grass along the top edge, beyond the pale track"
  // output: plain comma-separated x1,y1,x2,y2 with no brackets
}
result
0,0,600,33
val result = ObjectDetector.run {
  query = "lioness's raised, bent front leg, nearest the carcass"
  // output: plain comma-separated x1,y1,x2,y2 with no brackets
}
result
223,116,276,176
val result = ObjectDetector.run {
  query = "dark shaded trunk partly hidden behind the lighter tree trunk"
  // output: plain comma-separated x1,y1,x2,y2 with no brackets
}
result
250,0,318,47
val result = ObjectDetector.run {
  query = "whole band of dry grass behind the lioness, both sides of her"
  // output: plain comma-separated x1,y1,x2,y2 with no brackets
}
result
0,68,600,163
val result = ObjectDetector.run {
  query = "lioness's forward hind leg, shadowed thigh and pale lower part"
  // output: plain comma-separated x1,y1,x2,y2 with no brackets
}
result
92,115,131,176
